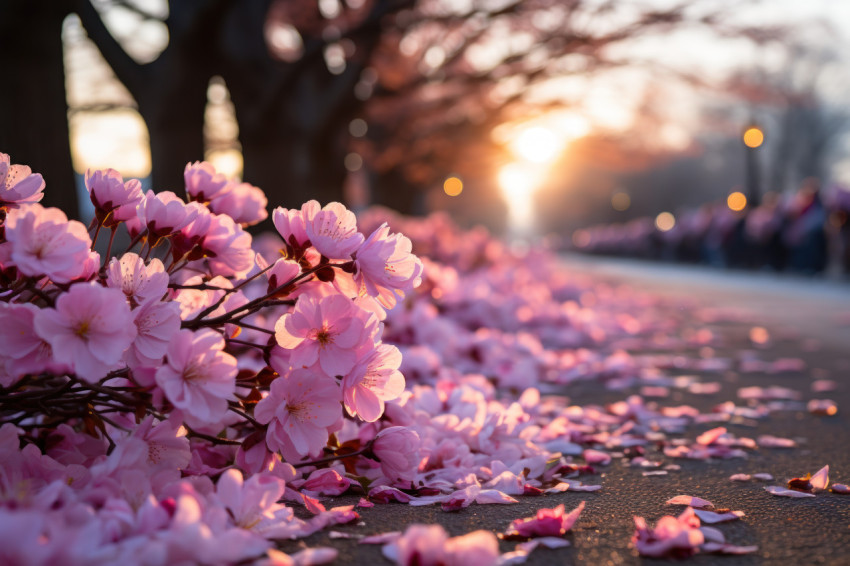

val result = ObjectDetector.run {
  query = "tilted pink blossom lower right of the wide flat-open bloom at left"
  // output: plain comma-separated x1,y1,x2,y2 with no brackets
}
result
156,330,236,423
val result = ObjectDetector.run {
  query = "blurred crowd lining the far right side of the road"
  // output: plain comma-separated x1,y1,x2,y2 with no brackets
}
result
572,179,850,276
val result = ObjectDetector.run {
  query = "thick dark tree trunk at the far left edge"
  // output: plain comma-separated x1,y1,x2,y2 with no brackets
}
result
0,0,79,218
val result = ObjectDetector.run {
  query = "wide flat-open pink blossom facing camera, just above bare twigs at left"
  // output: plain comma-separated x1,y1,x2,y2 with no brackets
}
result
33,283,136,382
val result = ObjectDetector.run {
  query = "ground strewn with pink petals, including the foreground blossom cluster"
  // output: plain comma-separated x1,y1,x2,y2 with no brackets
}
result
0,156,850,565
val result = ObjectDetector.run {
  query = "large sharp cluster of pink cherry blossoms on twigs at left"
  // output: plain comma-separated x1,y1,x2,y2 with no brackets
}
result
0,154,423,564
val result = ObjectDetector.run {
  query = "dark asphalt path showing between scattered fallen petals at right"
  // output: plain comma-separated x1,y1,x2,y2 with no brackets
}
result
274,257,850,566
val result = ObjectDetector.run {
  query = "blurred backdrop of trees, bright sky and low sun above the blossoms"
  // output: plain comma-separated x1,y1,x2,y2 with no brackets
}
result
0,0,850,234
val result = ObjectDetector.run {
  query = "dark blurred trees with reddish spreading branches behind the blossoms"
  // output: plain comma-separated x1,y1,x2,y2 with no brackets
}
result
0,0,796,220
